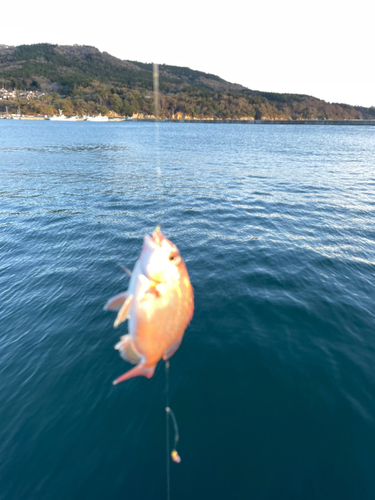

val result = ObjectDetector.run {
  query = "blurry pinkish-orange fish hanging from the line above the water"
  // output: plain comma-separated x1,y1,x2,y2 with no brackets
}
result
104,227,194,385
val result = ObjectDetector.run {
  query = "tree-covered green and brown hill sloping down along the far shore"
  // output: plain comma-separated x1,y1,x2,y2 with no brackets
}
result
0,44,375,120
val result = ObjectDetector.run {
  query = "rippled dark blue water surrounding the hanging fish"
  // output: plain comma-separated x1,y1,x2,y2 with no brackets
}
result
0,120,375,500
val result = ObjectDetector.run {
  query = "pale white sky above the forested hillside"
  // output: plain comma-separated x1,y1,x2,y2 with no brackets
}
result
0,0,375,106
